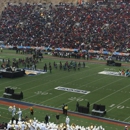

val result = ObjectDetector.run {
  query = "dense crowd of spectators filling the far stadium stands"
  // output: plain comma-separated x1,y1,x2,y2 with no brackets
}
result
0,2,130,52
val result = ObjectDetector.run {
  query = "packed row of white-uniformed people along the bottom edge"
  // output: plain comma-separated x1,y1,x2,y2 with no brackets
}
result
7,116,105,130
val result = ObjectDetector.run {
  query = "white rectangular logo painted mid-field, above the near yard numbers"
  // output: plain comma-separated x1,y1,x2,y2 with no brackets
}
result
55,86,90,94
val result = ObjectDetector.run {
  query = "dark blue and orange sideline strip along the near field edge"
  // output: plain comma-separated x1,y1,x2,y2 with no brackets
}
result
0,97,130,128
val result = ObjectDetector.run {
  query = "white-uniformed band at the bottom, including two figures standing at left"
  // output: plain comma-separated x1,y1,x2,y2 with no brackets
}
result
6,105,105,130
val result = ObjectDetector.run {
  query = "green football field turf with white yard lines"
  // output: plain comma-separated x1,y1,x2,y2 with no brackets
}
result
0,50,130,130
